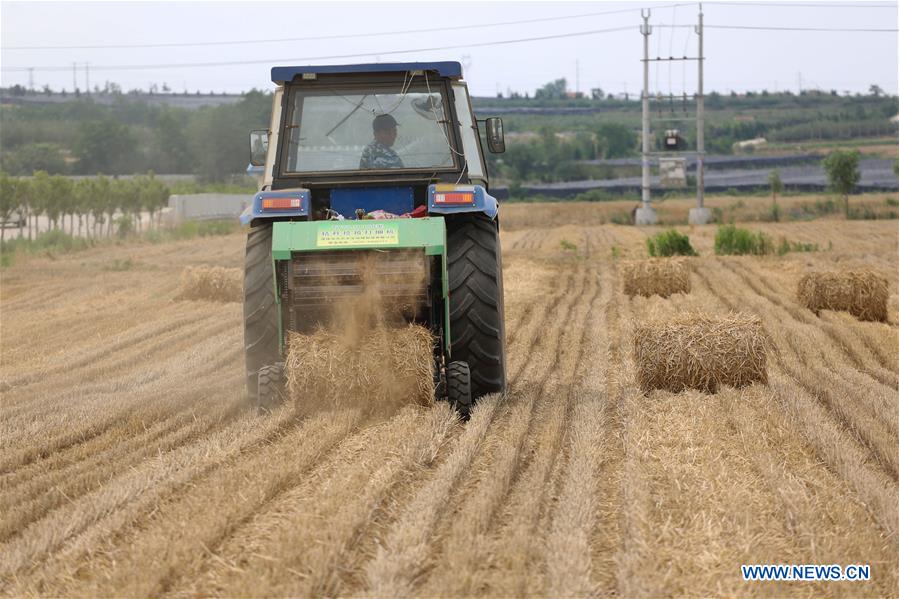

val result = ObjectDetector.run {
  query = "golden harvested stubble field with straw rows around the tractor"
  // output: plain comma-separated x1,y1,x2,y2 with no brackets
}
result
0,213,899,597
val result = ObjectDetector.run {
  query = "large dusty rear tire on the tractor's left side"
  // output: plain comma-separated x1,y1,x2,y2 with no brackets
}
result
243,224,281,401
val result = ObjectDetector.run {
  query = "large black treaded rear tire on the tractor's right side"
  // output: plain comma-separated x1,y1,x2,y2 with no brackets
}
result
446,214,506,400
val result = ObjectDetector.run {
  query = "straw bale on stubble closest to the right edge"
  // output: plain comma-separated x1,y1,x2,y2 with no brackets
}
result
797,268,889,322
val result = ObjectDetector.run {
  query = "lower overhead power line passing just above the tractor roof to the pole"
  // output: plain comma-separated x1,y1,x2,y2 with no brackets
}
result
2,25,635,71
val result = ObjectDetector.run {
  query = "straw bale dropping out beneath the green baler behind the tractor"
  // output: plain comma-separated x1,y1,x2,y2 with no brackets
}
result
285,324,434,407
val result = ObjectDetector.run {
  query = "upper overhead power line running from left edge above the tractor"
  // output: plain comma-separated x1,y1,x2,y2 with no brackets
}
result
3,2,696,54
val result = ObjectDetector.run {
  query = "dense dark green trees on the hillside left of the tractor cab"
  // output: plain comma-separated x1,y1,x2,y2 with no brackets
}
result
0,91,272,181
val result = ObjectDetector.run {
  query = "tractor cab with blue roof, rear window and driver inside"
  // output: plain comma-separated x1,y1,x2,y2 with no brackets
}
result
244,62,504,221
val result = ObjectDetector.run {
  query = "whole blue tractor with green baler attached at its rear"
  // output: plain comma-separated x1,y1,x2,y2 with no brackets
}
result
241,62,506,417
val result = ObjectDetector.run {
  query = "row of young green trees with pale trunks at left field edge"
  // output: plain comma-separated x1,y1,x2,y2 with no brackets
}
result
0,171,169,240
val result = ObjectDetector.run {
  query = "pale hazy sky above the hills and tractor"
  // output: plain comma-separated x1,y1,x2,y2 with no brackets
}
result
0,0,899,95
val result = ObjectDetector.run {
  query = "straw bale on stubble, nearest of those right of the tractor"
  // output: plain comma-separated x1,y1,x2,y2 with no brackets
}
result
634,313,768,393
